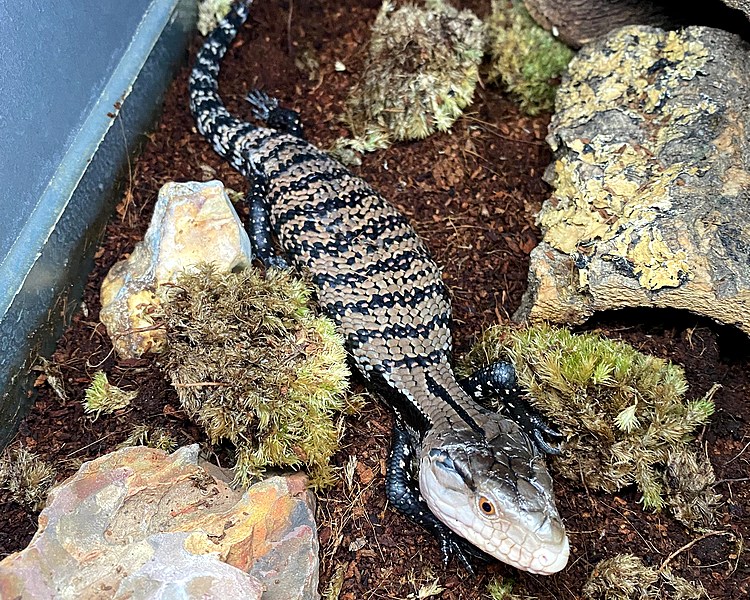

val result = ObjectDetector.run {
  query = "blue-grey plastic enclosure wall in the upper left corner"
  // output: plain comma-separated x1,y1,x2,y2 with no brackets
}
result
0,0,197,448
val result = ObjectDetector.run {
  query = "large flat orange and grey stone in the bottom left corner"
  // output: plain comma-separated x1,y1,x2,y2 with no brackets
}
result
0,445,318,600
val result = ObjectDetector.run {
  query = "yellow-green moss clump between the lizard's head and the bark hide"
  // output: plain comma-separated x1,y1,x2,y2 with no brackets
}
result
460,325,714,514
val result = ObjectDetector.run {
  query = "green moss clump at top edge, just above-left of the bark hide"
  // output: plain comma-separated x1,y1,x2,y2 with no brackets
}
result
487,0,574,115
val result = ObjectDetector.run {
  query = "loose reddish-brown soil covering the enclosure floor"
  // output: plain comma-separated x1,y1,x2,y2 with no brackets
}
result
0,0,750,600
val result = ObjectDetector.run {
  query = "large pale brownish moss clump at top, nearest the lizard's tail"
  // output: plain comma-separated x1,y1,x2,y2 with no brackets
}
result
334,0,484,152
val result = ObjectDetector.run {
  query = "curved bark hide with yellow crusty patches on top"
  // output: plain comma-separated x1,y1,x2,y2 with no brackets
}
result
514,27,750,333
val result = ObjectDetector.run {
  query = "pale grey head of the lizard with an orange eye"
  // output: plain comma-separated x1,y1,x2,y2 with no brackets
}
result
419,419,569,575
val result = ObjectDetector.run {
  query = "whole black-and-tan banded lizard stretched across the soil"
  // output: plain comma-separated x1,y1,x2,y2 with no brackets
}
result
190,0,568,573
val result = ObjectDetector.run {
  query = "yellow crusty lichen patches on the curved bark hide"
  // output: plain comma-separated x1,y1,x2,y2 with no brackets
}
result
538,27,718,290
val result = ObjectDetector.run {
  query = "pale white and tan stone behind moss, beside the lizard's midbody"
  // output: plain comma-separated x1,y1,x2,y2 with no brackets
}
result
99,181,252,358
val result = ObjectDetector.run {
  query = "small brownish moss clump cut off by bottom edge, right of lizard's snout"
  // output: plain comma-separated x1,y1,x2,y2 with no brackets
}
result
583,554,709,600
